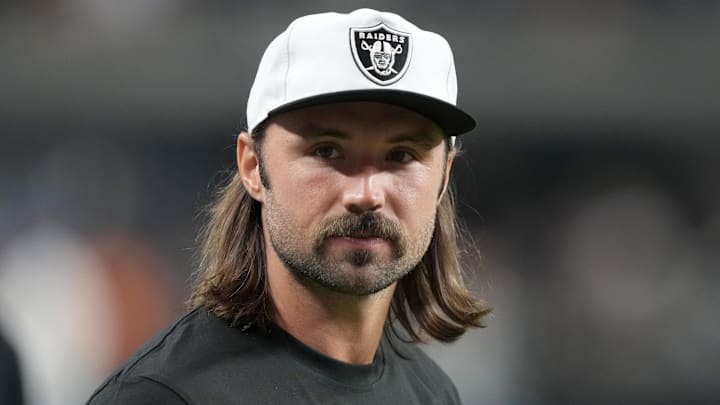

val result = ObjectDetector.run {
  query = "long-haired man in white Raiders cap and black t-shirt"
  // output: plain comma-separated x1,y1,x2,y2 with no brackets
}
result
84,9,488,404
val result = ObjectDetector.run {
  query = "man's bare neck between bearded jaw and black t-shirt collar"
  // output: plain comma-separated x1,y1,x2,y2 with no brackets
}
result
267,249,395,364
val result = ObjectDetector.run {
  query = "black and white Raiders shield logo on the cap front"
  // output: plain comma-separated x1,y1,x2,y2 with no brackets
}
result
350,24,412,86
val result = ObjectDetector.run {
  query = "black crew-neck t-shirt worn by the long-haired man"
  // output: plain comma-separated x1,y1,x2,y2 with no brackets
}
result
88,310,460,405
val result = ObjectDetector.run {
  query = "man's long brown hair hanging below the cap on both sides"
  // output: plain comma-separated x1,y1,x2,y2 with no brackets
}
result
188,134,490,342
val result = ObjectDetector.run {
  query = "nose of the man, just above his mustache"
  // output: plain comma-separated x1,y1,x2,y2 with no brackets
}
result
343,170,386,214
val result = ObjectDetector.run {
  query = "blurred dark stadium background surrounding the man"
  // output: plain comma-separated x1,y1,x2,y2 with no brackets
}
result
0,0,720,405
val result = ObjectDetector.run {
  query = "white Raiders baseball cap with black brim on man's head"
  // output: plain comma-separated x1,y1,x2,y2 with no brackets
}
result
247,9,476,136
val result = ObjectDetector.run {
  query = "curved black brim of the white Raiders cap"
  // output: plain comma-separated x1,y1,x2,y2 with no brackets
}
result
268,89,477,136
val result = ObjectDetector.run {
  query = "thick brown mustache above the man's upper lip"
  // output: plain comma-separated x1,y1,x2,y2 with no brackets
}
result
318,212,402,242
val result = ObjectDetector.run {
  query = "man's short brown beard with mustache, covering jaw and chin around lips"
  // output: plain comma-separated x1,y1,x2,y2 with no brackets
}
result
266,204,435,296
